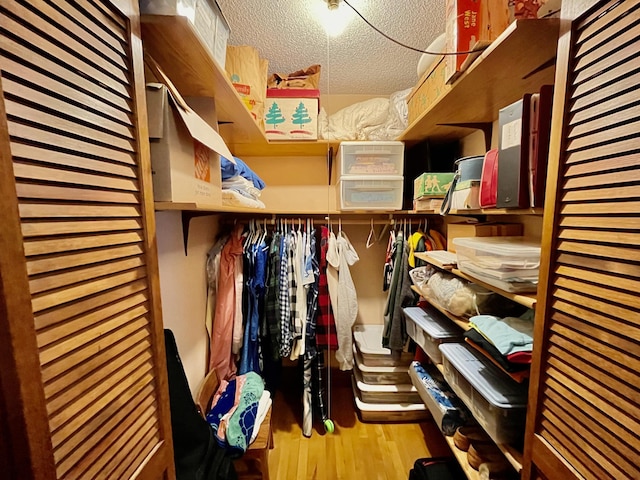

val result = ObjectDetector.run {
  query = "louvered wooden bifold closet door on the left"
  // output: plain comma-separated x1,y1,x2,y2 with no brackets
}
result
0,0,172,479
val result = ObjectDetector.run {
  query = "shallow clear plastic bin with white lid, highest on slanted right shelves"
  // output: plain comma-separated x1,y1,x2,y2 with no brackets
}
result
453,237,540,292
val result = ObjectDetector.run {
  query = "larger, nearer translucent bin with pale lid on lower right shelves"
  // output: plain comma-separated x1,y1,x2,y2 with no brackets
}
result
439,343,528,443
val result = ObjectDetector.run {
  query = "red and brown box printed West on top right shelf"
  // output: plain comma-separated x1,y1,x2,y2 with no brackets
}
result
445,0,513,83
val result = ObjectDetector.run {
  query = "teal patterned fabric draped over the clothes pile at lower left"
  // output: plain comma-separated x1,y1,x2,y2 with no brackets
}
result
226,372,264,454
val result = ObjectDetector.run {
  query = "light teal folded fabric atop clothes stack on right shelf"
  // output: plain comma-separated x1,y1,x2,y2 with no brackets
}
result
469,315,533,355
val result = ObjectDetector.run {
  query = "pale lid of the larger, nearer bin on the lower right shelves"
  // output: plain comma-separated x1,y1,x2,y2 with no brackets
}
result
438,343,528,409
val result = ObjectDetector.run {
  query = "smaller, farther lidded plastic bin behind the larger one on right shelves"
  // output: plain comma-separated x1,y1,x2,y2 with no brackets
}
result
403,307,462,363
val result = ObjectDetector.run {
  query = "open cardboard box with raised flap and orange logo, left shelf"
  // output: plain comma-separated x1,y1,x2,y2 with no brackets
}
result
147,84,233,205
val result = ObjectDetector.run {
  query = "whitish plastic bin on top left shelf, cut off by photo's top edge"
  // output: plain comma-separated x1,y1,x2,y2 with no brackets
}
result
140,0,231,69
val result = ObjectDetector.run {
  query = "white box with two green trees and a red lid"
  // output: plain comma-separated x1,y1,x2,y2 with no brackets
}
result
264,88,320,140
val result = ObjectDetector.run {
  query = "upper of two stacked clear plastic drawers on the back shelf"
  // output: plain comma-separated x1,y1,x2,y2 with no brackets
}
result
338,141,404,177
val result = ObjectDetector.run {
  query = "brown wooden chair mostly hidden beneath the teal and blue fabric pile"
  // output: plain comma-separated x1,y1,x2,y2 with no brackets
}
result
196,370,273,480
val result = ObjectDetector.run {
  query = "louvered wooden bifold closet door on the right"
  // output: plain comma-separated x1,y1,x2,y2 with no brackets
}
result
525,0,640,480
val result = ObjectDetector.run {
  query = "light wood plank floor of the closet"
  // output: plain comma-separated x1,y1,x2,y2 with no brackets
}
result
248,368,451,480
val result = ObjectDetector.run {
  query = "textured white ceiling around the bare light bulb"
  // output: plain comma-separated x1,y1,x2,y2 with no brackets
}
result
218,0,444,95
